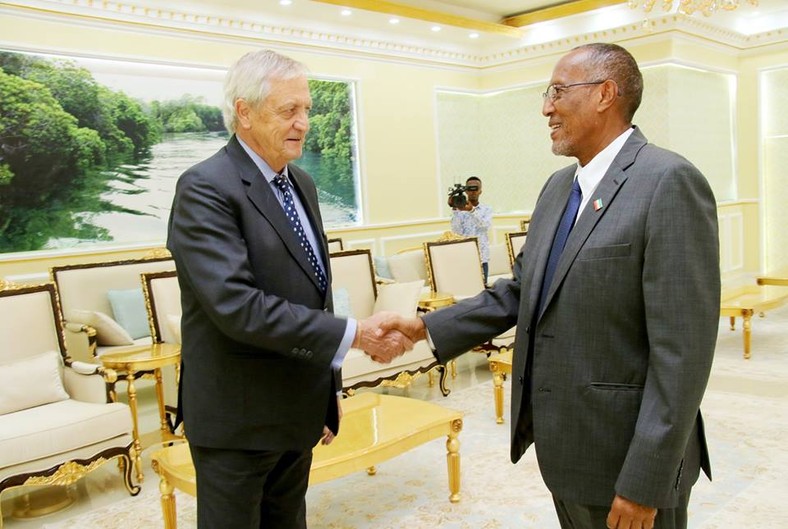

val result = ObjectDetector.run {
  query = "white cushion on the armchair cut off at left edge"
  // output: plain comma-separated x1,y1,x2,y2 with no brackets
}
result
0,351,69,415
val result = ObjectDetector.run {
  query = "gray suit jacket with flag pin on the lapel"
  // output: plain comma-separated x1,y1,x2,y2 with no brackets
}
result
425,129,720,508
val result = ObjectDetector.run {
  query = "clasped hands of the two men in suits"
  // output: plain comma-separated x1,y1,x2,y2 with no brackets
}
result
353,312,427,364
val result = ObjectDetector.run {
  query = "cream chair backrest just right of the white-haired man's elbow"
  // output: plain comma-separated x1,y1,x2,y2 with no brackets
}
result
330,249,378,318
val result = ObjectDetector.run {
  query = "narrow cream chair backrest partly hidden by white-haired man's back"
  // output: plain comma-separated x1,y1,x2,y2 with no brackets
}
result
140,270,182,343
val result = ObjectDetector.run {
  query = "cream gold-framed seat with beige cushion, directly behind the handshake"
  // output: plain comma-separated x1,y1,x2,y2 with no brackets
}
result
330,249,449,395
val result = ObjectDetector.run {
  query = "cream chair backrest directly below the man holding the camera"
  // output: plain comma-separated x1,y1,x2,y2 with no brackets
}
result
424,237,484,297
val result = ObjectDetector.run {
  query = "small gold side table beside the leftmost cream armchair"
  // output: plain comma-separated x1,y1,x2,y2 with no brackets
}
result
99,343,181,483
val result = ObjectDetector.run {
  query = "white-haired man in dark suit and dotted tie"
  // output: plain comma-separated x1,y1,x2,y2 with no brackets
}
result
167,51,412,529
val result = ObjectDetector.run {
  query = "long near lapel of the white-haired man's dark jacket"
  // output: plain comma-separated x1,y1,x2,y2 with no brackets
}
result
227,136,322,289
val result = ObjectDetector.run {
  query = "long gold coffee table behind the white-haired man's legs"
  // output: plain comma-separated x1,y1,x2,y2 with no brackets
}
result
151,392,463,529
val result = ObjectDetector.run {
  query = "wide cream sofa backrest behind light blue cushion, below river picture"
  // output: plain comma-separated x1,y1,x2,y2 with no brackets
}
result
49,257,175,319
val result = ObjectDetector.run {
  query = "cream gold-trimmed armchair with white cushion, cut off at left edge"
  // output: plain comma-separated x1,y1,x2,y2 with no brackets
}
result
0,281,140,527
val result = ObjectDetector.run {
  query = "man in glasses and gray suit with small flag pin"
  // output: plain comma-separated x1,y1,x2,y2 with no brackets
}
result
380,44,720,529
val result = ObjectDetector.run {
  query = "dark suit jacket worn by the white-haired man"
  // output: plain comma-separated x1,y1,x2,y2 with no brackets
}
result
167,137,346,450
